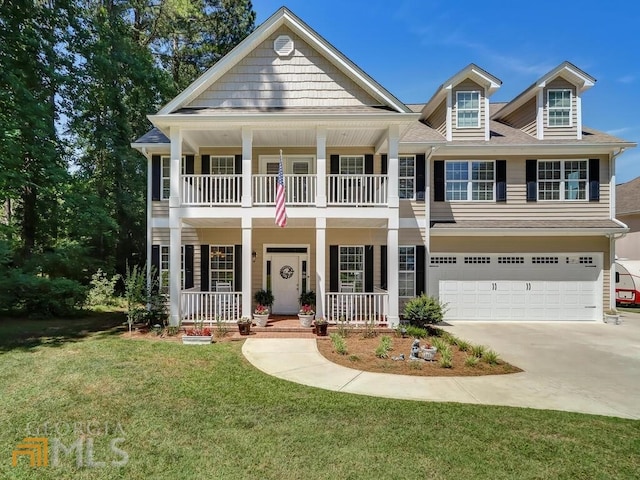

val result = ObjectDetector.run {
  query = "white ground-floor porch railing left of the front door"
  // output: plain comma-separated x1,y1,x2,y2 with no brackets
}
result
180,291,242,326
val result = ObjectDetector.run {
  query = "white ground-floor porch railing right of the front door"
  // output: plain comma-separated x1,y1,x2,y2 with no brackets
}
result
325,291,389,325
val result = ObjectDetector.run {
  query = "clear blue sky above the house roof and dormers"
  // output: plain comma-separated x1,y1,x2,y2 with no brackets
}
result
253,0,640,183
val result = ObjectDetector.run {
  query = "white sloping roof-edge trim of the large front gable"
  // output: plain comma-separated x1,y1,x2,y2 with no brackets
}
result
158,7,411,115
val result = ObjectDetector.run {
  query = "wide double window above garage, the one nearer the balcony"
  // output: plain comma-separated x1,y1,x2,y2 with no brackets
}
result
445,160,496,201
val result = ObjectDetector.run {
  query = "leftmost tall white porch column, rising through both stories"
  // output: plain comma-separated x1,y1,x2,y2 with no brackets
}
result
169,127,182,325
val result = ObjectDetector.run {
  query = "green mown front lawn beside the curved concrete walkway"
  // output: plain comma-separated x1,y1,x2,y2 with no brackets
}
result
0,314,640,480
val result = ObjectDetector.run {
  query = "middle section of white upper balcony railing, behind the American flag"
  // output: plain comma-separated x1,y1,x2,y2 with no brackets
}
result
253,174,316,205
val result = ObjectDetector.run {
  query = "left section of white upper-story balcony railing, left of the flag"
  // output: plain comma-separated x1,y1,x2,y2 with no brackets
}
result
182,175,242,205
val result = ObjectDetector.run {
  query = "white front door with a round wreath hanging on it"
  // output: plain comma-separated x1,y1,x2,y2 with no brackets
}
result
271,254,302,315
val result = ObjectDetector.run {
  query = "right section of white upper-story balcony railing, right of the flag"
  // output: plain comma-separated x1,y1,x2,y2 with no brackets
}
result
327,175,388,206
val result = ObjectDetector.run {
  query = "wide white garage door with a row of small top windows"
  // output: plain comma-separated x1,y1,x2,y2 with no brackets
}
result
429,252,603,321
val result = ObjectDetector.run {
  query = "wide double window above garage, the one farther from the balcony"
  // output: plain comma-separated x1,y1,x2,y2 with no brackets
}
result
538,160,588,200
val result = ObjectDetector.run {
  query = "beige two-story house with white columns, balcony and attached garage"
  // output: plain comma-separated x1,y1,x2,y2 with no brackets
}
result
133,8,634,325
